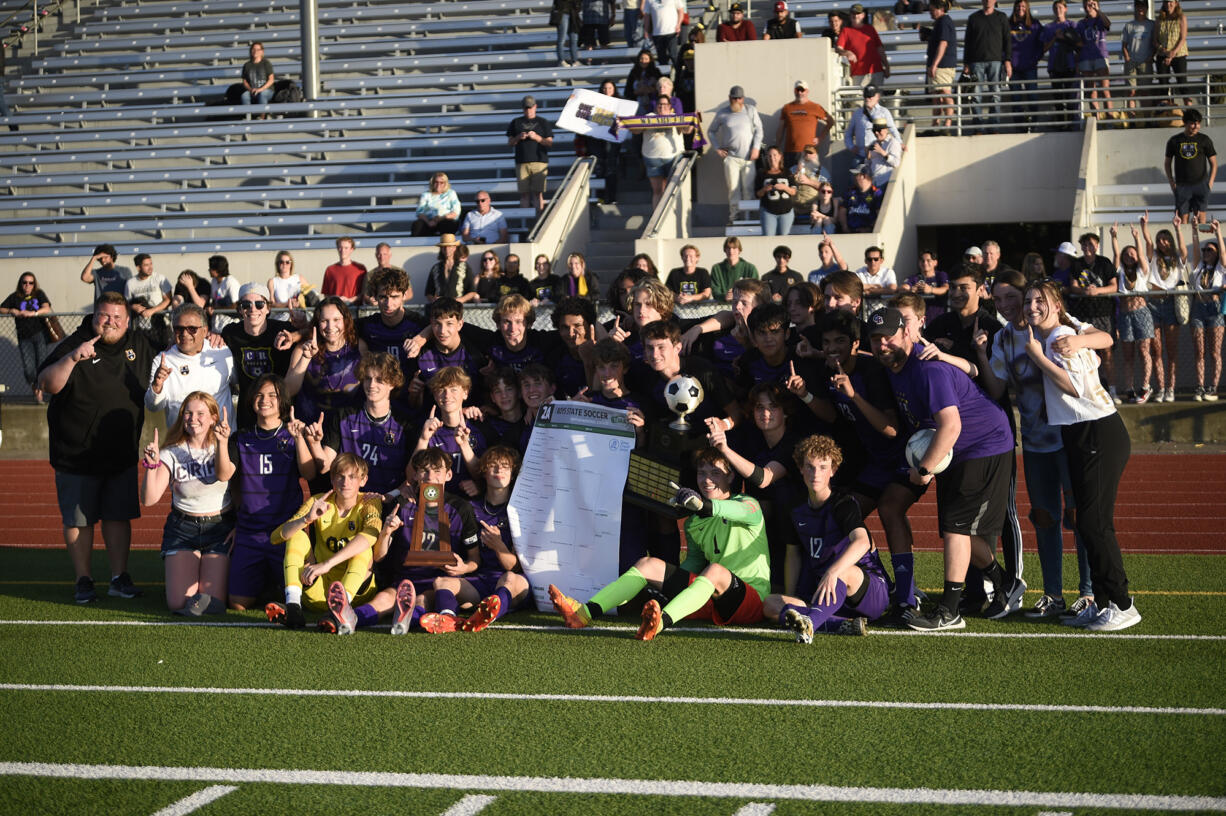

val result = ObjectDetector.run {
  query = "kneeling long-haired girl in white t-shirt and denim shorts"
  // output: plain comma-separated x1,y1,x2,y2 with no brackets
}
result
141,391,234,614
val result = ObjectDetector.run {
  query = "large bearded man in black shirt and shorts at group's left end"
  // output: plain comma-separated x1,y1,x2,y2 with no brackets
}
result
38,292,153,604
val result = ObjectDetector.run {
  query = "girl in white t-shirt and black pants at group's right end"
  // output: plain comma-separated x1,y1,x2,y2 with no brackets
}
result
1024,279,1141,632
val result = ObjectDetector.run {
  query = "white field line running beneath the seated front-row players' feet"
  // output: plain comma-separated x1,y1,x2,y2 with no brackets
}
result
0,619,1226,641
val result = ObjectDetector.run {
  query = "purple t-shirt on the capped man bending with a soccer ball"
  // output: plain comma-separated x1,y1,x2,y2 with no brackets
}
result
889,343,1014,462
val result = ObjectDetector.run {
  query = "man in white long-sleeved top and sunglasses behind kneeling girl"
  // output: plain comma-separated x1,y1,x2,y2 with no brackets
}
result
145,300,235,426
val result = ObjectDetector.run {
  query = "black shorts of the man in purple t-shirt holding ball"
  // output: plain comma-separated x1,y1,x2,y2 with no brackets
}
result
935,451,1014,542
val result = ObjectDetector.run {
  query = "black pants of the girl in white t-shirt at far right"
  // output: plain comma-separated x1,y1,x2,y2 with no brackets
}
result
1060,413,1132,609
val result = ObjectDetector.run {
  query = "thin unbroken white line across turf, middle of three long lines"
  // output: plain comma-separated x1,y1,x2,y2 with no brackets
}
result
0,682,1226,717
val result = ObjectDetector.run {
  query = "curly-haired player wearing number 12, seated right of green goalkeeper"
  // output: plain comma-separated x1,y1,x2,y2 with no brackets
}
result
765,436,890,643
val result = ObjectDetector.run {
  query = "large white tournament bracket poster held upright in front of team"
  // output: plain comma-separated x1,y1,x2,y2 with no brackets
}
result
508,401,634,609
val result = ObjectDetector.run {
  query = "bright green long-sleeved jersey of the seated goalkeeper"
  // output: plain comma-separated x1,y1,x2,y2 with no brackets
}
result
680,494,770,598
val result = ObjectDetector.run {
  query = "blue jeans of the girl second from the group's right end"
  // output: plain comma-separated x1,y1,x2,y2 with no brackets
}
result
1021,448,1094,598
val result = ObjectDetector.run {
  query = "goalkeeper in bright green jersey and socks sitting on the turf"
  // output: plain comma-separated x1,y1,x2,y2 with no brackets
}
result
549,448,770,641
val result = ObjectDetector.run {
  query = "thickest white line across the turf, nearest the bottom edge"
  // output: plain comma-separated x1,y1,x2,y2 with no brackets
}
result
0,762,1226,812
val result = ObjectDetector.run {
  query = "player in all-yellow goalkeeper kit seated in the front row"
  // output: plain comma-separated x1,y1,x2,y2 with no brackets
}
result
265,453,383,635
